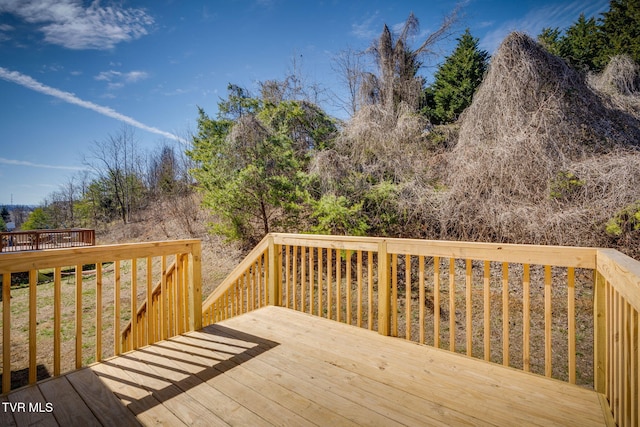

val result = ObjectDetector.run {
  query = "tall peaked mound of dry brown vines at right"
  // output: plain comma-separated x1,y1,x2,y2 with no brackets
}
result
440,33,640,254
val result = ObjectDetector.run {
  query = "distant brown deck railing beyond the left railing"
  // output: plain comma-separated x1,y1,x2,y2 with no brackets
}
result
0,228,96,253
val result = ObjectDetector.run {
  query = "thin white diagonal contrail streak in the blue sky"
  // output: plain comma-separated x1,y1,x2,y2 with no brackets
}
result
0,67,186,143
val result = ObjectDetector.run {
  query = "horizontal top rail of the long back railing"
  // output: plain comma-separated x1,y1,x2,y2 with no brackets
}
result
270,233,598,269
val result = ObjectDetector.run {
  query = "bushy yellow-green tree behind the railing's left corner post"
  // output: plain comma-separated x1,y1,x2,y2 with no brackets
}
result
187,85,336,244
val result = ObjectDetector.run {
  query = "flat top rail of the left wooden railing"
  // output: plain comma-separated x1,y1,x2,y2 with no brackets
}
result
0,239,200,274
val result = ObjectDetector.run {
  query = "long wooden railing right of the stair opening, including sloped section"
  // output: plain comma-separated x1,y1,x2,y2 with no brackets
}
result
203,234,640,426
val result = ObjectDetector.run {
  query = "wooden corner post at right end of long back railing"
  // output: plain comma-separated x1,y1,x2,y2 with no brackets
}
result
593,270,607,393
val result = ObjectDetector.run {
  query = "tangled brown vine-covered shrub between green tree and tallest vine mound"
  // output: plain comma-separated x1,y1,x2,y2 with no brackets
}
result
311,103,437,237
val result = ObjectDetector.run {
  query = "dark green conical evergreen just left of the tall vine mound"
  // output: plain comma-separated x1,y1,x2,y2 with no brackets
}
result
426,29,489,124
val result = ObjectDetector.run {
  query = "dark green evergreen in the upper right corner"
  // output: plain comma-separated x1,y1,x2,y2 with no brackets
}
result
600,0,640,67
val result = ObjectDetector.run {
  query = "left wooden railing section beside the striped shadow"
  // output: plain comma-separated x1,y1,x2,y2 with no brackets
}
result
0,240,202,393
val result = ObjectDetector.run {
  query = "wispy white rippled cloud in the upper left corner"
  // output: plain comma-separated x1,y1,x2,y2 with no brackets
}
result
0,0,154,49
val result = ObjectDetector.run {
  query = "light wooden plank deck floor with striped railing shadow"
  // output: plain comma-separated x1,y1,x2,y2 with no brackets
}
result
0,307,606,427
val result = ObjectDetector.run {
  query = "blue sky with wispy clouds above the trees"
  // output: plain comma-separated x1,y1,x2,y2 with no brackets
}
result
0,0,608,205
